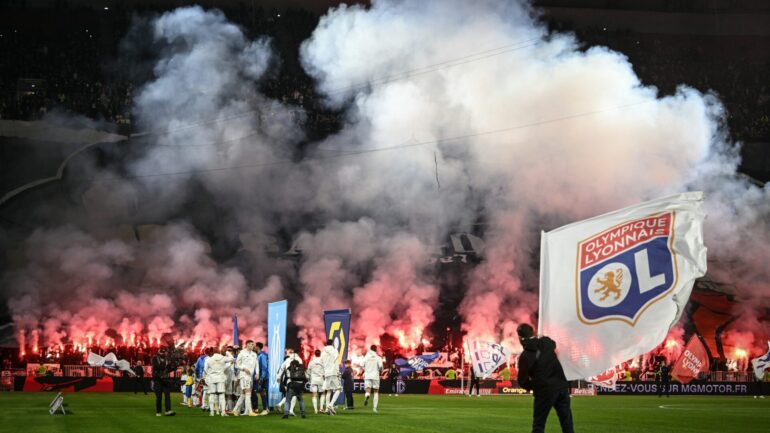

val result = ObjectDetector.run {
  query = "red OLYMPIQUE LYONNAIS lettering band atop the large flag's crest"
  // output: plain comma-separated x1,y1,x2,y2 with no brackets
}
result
580,212,673,268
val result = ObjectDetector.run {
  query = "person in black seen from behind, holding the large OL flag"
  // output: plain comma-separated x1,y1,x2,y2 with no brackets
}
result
516,323,575,433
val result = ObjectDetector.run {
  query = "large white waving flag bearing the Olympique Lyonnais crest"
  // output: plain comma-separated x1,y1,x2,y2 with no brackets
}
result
539,192,706,380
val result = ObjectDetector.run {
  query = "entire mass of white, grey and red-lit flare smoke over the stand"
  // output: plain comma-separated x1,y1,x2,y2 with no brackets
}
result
6,0,770,360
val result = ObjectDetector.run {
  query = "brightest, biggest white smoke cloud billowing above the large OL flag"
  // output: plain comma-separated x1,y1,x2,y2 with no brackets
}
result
302,0,768,350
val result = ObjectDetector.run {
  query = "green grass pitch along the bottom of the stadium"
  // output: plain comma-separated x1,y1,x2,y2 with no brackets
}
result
0,393,770,433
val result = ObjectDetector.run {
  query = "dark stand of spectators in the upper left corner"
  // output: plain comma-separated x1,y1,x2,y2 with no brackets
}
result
0,9,133,123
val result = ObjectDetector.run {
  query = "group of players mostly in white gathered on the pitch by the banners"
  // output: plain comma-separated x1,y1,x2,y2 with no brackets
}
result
188,340,383,418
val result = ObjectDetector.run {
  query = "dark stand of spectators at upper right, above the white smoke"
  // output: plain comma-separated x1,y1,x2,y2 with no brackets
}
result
575,28,770,141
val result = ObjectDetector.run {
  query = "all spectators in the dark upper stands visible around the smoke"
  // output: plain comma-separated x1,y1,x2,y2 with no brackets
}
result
0,5,770,141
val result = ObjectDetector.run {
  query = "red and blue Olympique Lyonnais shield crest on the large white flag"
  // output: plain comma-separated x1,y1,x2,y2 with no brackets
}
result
575,211,678,326
